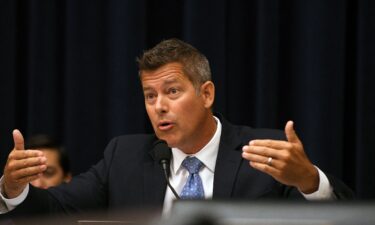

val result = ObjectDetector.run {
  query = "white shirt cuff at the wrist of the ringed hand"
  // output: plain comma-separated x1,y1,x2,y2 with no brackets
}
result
301,166,336,201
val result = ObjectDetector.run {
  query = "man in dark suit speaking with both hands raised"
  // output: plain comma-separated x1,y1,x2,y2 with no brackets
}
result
0,39,351,218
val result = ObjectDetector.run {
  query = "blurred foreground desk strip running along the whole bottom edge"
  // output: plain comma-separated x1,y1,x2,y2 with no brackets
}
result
0,201,375,225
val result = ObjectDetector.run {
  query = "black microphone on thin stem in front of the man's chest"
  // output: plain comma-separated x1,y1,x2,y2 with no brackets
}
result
154,140,180,199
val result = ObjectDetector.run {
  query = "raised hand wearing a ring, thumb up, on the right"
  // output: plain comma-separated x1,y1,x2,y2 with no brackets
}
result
242,121,319,194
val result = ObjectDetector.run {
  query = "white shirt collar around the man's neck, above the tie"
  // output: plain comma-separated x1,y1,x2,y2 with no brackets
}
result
171,116,221,174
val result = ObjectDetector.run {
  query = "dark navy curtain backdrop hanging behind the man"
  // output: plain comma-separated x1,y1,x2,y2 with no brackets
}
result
0,0,375,199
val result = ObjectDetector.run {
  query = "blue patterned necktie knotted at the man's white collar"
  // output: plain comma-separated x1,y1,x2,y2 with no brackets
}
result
180,157,204,199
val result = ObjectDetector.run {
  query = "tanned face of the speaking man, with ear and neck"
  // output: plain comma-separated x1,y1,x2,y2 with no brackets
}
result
141,63,216,153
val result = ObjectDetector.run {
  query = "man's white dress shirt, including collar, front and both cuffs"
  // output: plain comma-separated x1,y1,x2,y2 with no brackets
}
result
0,117,335,215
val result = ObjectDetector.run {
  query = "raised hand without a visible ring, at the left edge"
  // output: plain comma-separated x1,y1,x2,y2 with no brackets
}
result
2,130,47,198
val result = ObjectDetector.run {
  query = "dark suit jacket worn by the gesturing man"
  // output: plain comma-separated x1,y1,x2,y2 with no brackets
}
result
5,118,352,218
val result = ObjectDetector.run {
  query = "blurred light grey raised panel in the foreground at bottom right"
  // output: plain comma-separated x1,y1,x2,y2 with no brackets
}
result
158,201,375,225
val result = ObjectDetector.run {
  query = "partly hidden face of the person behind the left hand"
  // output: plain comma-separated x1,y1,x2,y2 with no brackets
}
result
31,149,70,189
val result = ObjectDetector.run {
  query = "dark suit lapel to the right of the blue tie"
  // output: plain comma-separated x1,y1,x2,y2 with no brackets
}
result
213,116,243,199
